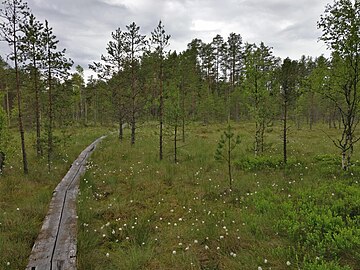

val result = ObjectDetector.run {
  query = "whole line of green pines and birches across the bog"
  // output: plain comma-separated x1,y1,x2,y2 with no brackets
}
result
0,0,360,173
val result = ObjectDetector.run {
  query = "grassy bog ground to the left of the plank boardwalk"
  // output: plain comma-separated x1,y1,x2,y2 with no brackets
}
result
0,125,108,269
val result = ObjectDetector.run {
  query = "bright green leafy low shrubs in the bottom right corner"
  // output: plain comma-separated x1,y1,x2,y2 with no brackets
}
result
278,183,360,264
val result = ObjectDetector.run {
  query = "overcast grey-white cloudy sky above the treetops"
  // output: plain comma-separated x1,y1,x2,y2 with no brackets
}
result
0,0,333,79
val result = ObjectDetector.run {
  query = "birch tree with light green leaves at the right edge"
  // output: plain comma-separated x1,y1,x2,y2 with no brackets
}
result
318,0,360,170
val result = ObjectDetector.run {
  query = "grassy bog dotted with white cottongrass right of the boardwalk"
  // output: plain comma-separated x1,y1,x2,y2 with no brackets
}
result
78,121,360,270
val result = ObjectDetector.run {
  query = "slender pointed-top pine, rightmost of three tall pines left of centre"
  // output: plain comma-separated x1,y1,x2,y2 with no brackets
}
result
151,21,171,160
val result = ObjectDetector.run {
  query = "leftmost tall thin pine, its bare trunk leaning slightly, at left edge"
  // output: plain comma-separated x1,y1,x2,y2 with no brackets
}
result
0,0,30,174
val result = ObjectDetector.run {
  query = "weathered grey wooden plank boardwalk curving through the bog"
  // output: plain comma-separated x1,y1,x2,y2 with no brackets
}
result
26,136,105,270
